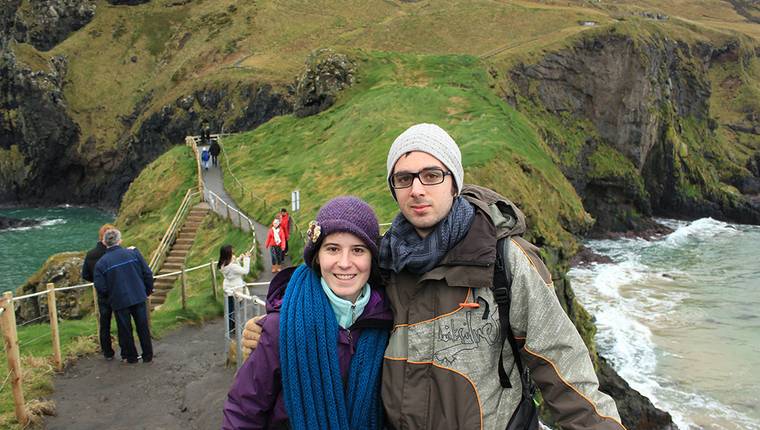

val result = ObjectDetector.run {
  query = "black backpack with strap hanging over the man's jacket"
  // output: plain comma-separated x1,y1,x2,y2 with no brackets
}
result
492,236,538,430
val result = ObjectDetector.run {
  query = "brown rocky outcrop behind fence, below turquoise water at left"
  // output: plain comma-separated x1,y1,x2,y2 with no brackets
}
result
14,252,94,324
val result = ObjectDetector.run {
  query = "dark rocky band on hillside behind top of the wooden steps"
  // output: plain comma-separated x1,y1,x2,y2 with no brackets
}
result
72,82,292,207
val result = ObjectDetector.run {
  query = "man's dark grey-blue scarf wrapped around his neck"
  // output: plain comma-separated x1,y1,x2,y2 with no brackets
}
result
380,196,475,275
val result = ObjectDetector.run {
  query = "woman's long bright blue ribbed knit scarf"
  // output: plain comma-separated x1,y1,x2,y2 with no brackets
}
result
280,264,388,430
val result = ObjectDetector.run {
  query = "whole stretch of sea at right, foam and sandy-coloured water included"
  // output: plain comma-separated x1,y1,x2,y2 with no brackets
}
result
569,218,760,430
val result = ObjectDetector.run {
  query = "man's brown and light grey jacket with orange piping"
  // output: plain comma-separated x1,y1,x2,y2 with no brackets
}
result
382,186,624,430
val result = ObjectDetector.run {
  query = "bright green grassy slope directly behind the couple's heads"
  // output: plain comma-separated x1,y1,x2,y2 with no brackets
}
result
223,52,587,256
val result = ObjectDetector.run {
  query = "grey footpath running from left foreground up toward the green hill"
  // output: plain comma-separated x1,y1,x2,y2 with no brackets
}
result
45,147,289,430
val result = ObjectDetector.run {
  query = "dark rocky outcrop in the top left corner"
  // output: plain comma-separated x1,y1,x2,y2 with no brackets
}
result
15,0,96,51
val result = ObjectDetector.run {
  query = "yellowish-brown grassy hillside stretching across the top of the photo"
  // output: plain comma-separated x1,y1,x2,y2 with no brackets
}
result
14,0,760,146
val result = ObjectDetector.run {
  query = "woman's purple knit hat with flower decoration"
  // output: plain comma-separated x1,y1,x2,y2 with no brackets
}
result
303,196,380,267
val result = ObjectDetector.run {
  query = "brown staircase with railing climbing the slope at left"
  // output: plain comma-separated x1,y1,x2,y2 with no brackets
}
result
150,203,211,310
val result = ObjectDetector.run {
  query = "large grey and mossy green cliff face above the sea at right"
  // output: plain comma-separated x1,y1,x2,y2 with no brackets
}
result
504,29,760,232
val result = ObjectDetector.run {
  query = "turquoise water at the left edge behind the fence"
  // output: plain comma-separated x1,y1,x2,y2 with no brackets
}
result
0,207,114,292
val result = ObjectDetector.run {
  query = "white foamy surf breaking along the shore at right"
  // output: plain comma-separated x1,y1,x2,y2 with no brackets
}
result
569,218,760,430
